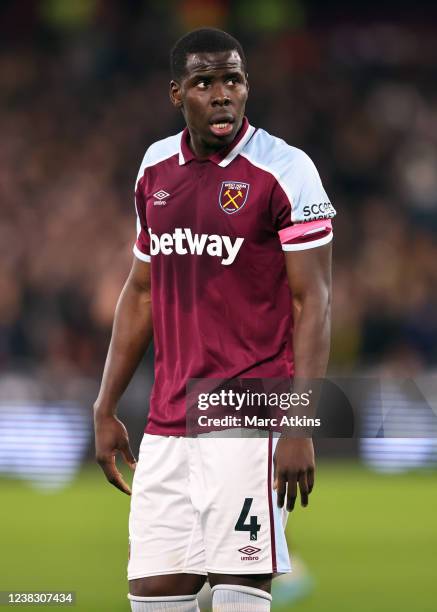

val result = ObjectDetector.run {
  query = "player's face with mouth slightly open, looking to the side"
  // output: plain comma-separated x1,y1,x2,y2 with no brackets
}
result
170,51,248,156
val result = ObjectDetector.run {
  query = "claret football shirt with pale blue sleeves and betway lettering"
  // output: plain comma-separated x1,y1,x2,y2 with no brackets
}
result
134,119,335,435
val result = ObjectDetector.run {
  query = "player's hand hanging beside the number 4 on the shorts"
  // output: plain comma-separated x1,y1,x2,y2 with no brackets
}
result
273,437,315,512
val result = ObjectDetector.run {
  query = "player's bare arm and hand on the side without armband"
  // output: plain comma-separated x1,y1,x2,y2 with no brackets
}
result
94,257,153,495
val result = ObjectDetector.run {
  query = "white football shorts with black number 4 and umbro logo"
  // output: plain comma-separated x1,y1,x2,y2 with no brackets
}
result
128,434,291,580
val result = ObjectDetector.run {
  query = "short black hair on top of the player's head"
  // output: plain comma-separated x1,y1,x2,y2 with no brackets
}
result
170,28,246,80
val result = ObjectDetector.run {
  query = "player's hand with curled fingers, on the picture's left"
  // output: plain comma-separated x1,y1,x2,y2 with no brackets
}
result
94,414,136,495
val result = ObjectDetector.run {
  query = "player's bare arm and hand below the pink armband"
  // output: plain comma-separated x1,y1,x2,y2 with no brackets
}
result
274,242,332,511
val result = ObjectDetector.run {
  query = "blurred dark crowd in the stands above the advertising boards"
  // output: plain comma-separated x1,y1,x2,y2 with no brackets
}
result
0,0,437,378
